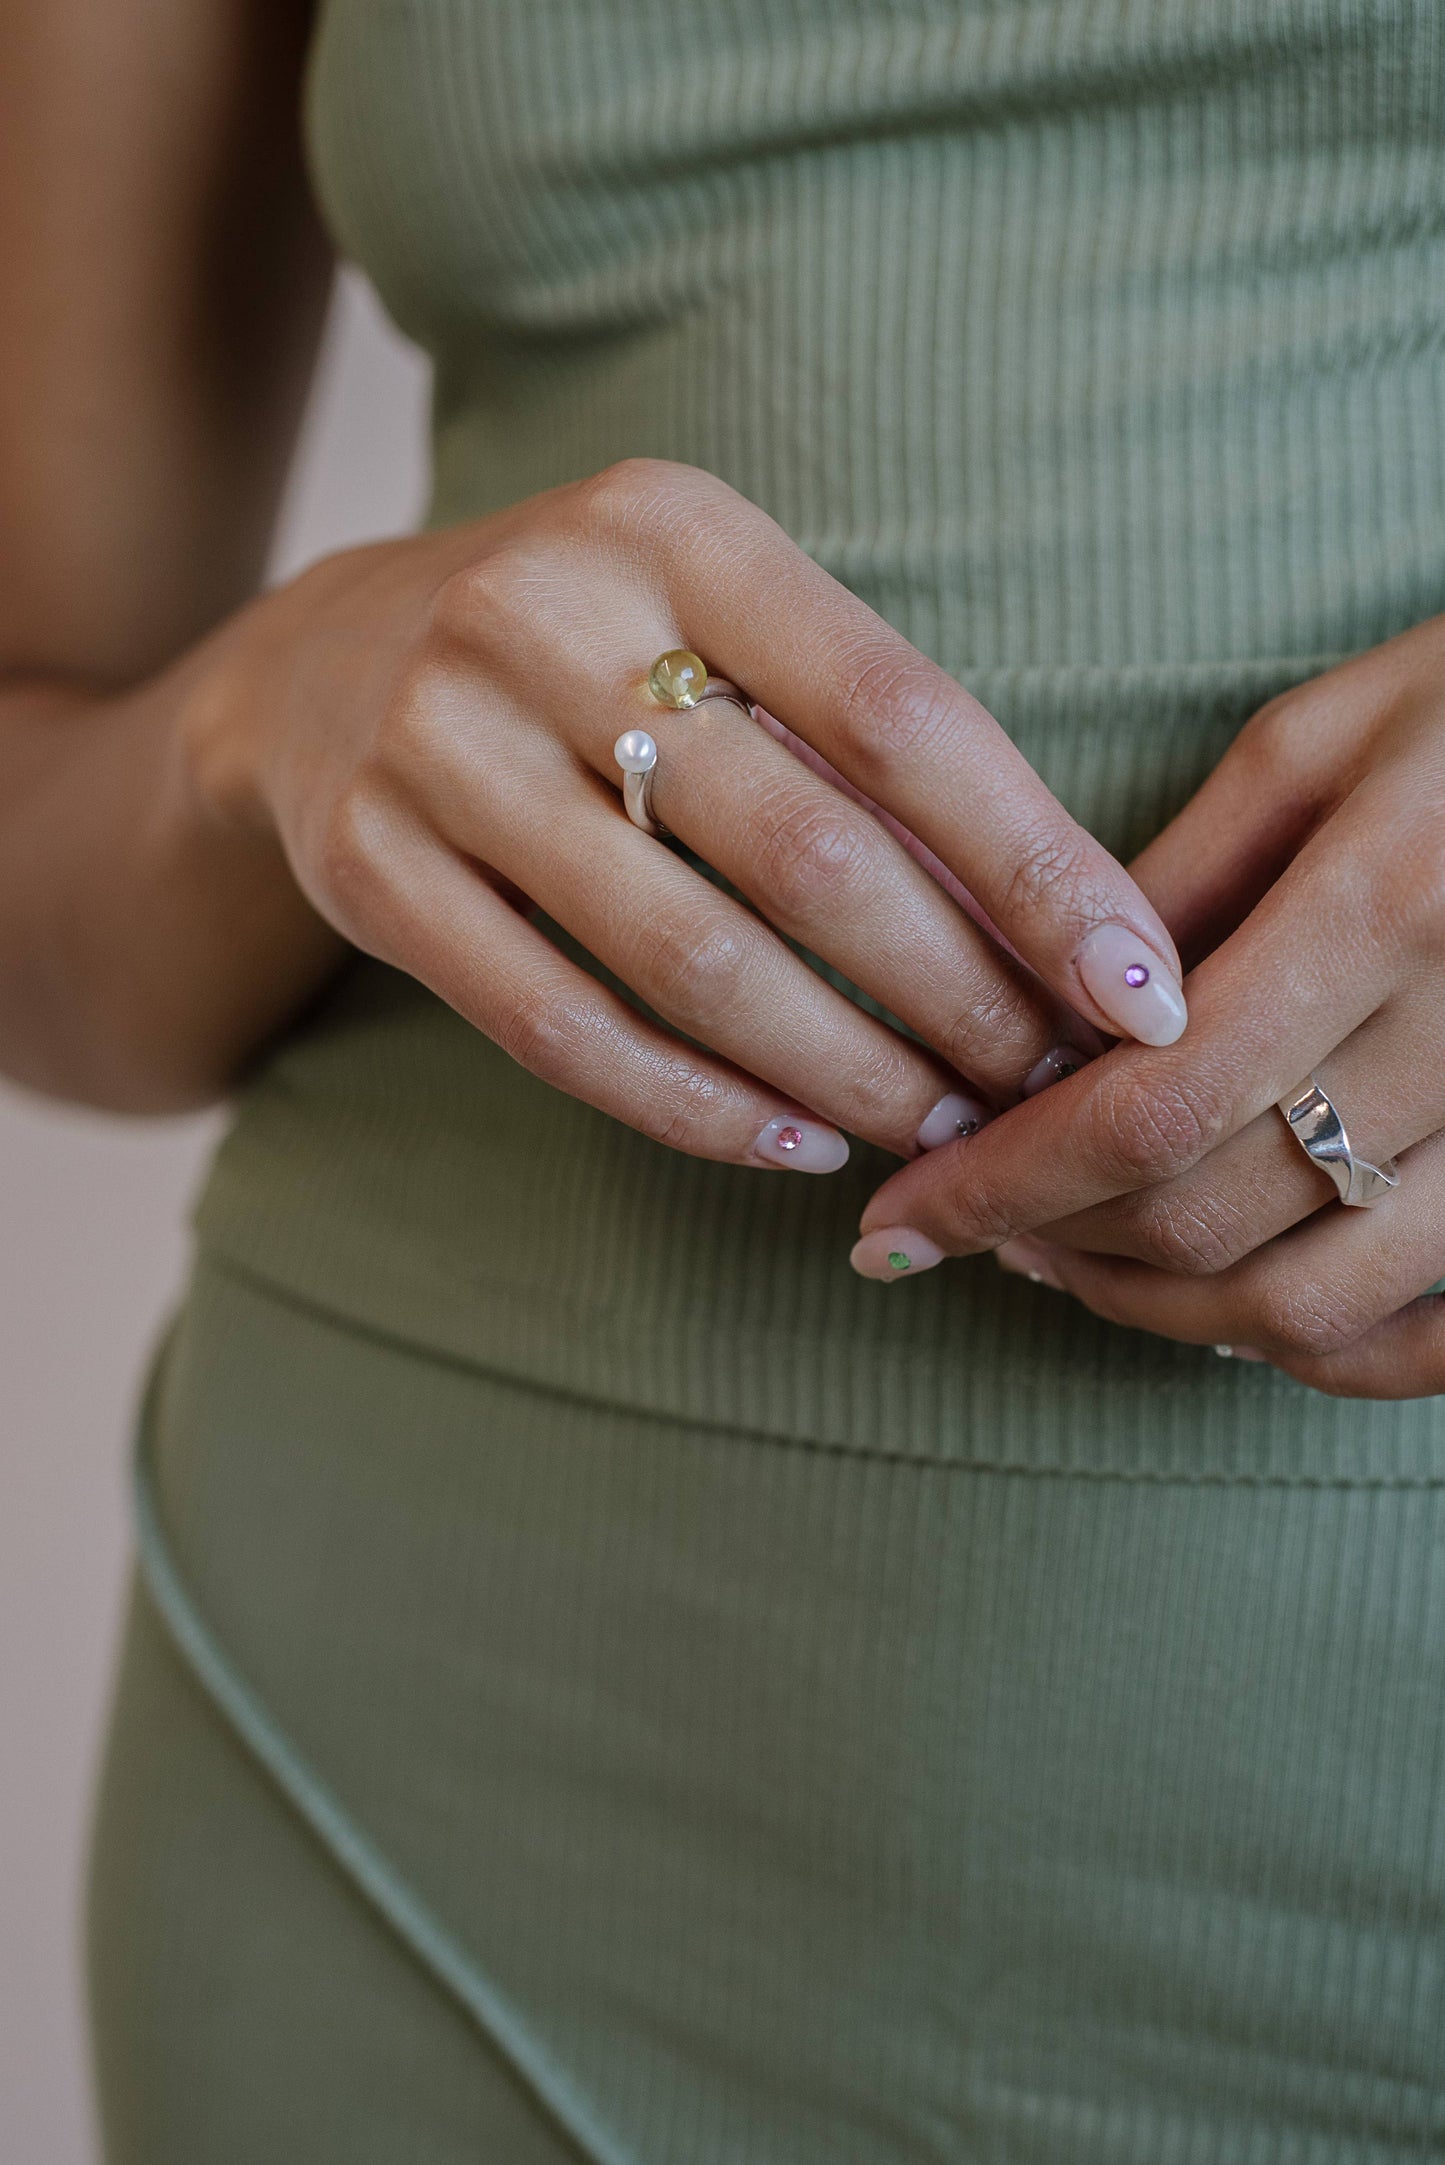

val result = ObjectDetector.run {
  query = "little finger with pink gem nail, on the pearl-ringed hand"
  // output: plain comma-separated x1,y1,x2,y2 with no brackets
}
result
333,816,847,1173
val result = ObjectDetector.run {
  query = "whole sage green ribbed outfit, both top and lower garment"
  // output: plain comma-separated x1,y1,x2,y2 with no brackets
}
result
93,0,1445,2165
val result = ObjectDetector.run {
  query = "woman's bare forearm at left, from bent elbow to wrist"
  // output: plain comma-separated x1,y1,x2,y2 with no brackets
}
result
0,665,344,1113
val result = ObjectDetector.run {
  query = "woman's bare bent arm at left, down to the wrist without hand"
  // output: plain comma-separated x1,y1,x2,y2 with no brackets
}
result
0,0,342,1111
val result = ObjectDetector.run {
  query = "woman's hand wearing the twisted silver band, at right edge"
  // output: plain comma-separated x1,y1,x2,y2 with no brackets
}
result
856,617,1445,1396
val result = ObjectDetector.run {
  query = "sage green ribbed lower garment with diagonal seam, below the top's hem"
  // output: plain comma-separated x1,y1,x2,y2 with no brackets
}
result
93,1264,1445,2165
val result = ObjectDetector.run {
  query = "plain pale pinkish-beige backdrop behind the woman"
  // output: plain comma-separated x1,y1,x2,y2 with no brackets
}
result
0,275,427,2165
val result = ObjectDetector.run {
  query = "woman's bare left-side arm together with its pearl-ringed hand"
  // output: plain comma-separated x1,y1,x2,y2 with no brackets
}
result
0,0,1179,1163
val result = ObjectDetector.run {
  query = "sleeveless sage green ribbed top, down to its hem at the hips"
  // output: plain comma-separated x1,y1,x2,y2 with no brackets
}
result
199,0,1445,1464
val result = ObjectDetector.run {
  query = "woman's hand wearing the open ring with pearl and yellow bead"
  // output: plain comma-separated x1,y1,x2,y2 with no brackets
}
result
182,459,1183,1171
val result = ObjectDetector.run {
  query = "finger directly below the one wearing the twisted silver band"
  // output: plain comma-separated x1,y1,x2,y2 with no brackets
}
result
999,1134,1445,1373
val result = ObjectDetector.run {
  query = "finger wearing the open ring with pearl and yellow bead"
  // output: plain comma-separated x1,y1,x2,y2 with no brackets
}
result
604,699,1092,1104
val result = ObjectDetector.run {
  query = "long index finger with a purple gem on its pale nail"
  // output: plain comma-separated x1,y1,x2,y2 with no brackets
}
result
571,459,1187,1044
